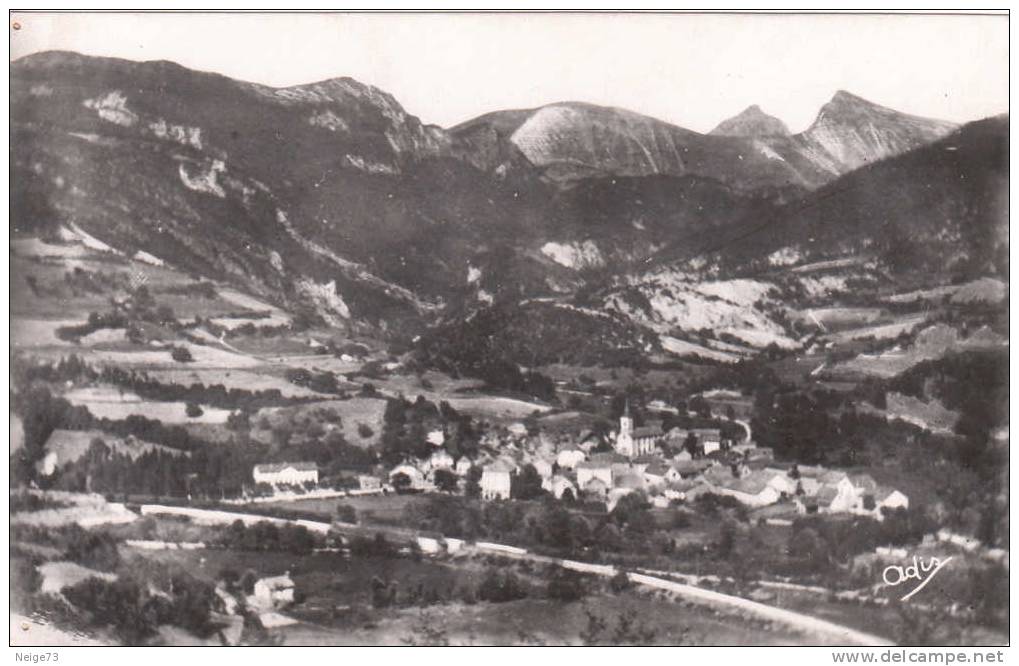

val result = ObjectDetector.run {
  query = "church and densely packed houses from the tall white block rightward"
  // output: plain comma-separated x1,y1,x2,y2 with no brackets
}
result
468,401,909,519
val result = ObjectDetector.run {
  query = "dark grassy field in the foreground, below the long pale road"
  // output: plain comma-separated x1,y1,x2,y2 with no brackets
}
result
128,550,804,645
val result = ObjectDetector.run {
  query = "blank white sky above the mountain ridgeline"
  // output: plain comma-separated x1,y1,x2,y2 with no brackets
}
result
9,13,1009,131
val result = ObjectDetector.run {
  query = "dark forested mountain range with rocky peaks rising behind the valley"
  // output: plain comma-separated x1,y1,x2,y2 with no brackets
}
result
11,52,1008,368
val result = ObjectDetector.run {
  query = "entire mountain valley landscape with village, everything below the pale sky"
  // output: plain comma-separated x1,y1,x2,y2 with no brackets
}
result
9,52,1010,645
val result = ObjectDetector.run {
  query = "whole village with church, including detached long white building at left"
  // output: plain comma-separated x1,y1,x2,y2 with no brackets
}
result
253,391,909,524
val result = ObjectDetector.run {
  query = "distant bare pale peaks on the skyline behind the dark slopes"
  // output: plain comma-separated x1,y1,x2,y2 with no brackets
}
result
451,92,954,193
